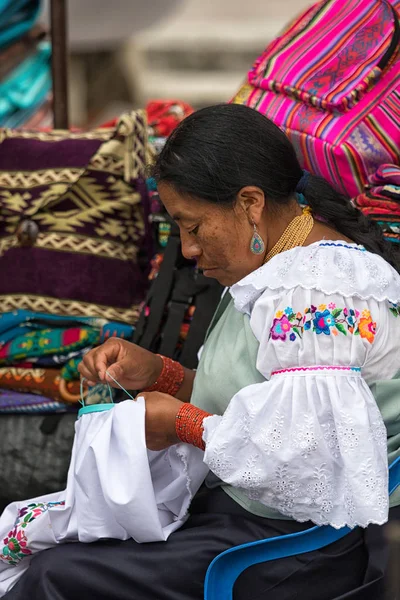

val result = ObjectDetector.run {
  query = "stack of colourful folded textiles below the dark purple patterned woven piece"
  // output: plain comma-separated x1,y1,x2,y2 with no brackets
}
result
0,310,133,412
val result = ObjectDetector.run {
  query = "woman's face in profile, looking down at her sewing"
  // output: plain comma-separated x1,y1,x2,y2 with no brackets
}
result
158,182,264,286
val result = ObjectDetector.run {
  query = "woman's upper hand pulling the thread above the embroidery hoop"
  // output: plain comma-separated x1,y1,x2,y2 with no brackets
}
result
79,338,163,391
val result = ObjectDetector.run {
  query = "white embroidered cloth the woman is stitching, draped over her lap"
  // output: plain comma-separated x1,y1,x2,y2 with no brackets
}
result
0,398,208,597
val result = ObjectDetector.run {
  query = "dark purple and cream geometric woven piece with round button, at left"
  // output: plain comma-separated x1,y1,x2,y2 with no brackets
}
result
0,111,152,323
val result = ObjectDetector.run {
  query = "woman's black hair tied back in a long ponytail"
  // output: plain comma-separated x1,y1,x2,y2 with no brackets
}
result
153,104,400,271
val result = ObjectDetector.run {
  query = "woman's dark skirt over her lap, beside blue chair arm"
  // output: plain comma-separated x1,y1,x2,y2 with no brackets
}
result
4,488,396,600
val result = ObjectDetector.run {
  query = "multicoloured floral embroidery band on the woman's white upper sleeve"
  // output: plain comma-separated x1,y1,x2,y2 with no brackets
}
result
269,302,376,344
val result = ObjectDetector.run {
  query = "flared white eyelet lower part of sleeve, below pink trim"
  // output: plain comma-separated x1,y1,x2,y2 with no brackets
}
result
204,373,389,528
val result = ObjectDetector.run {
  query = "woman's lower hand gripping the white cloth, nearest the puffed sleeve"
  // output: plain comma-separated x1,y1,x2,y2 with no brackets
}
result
137,392,183,450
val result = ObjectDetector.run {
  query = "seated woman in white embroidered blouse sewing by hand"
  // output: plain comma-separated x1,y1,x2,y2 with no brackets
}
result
5,105,400,600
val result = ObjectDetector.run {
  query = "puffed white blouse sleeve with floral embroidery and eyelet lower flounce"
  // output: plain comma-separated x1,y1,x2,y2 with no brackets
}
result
204,287,400,528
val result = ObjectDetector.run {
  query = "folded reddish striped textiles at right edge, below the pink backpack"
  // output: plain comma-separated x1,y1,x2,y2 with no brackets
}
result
353,165,400,243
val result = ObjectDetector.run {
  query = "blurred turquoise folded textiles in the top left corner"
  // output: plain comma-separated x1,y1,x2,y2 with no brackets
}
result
0,0,52,127
